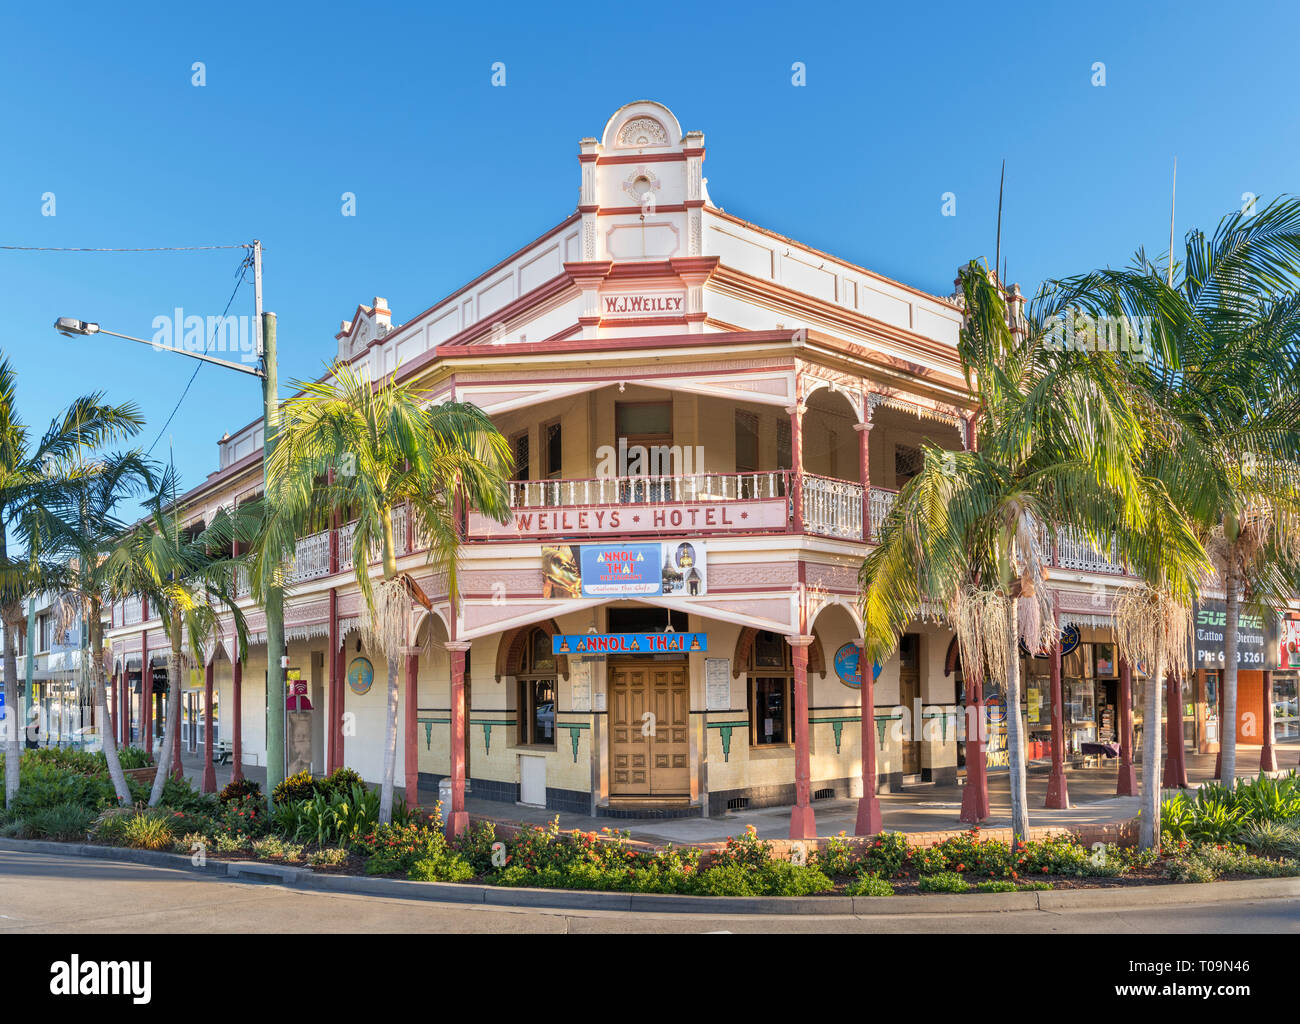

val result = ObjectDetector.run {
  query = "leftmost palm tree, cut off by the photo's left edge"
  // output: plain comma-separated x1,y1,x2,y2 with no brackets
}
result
0,356,144,804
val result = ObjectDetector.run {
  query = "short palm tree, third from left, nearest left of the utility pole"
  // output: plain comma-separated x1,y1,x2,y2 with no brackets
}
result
103,469,247,807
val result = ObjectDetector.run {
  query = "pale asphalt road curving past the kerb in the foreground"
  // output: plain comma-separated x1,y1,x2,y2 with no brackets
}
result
0,851,1300,934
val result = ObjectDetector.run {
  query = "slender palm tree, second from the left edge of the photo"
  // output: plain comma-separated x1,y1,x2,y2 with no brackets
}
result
42,452,152,804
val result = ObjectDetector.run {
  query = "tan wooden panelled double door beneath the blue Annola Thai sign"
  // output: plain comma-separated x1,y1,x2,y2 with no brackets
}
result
610,660,690,797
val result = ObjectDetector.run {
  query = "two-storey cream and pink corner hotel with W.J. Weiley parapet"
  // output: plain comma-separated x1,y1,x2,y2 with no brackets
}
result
104,101,1279,820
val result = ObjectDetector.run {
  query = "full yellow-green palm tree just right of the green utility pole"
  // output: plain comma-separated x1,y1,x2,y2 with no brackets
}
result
250,363,510,821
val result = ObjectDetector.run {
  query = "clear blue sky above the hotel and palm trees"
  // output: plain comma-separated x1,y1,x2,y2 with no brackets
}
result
0,0,1300,512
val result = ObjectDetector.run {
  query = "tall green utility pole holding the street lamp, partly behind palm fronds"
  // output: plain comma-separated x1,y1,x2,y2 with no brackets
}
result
252,239,285,804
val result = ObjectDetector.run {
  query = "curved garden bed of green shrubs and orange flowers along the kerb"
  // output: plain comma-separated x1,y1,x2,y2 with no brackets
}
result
0,755,1300,897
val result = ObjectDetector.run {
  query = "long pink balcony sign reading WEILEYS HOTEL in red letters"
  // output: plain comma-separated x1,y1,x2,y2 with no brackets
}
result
469,498,787,538
